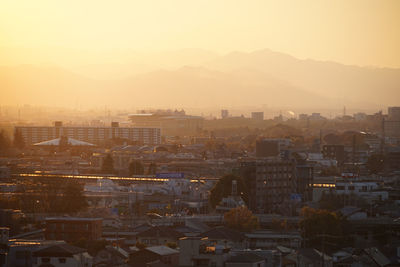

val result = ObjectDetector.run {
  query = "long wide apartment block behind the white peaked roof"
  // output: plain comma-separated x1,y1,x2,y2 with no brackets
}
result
15,122,161,145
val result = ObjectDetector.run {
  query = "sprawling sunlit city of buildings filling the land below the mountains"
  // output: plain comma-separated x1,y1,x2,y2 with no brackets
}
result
0,107,400,267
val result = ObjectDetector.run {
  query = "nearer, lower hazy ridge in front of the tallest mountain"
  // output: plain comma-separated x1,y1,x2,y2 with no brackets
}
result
0,65,328,107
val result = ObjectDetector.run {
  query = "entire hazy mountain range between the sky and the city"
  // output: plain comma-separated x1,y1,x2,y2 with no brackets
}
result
0,50,400,108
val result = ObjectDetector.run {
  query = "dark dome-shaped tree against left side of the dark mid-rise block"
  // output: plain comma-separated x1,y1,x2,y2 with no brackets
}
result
210,174,248,207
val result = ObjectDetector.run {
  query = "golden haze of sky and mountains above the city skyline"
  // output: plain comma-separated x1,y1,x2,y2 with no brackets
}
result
0,1,400,112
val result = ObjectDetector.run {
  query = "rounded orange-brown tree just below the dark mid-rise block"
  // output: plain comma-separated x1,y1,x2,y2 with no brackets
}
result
224,207,259,231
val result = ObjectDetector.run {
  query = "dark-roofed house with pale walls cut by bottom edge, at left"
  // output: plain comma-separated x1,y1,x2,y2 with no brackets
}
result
32,244,92,267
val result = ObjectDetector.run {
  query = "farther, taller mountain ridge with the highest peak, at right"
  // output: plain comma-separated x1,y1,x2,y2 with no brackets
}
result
204,49,400,106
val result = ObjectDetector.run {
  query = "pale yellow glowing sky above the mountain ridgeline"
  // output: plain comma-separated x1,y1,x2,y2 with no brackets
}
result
0,0,400,67
